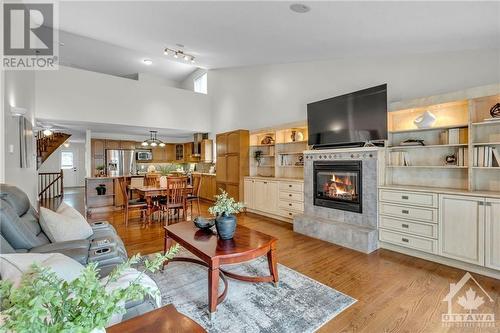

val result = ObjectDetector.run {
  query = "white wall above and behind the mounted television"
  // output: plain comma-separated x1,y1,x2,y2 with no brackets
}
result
208,49,500,133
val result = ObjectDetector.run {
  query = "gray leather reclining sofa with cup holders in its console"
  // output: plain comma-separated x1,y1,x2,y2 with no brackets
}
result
0,184,156,320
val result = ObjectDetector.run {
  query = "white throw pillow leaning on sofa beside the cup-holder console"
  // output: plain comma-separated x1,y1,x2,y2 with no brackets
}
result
40,207,93,242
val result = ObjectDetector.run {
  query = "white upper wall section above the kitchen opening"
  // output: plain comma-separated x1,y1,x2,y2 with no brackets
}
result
36,66,211,132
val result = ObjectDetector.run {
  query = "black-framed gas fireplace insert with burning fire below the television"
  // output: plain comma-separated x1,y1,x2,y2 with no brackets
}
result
313,161,362,213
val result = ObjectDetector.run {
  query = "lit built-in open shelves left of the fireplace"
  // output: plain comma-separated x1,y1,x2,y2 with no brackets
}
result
249,124,308,179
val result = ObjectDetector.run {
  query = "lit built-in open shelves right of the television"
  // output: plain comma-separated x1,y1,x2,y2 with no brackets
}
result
385,88,500,192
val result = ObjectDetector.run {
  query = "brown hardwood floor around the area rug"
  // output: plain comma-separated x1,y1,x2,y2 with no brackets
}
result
64,188,500,333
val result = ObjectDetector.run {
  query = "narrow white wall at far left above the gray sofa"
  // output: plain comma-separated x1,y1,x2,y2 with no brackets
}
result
2,71,38,207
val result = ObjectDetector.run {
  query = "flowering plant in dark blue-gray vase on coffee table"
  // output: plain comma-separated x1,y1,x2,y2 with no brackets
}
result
208,189,245,239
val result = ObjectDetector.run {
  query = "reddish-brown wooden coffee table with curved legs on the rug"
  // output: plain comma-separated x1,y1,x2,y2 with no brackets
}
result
163,222,278,319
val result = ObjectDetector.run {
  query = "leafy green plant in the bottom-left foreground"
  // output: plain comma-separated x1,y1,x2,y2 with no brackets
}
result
0,245,179,333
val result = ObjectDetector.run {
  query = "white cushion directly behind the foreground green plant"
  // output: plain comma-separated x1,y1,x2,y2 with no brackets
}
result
0,253,83,286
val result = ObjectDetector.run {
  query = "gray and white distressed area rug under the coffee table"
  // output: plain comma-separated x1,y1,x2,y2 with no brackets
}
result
144,249,356,333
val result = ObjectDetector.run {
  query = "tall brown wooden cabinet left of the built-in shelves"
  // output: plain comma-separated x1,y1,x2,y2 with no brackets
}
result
216,130,250,201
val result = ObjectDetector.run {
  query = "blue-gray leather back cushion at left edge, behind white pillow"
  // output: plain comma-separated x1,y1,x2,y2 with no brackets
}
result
0,199,49,250
